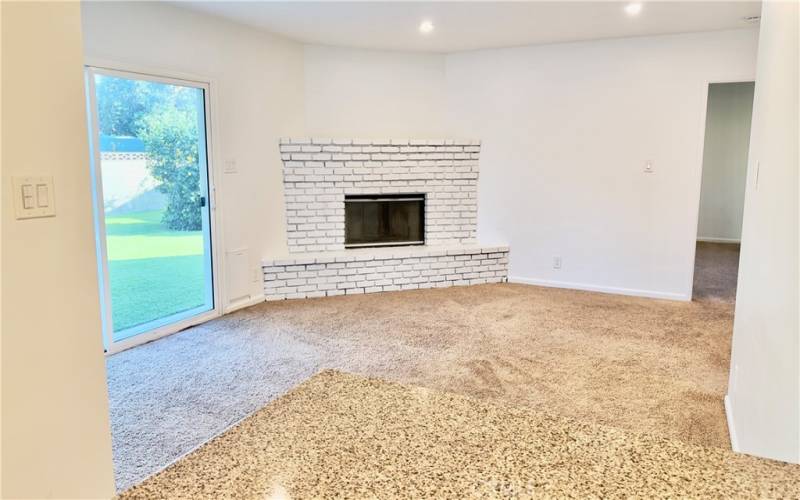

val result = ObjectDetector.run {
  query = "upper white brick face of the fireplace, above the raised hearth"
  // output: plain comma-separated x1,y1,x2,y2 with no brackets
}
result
280,139,481,252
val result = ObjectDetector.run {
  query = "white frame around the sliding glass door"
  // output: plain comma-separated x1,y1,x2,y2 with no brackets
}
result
85,61,224,355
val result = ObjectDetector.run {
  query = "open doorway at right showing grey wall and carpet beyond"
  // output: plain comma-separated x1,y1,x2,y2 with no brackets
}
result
692,82,755,304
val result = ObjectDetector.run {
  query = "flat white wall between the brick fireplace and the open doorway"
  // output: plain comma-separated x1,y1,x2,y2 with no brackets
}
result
446,29,757,300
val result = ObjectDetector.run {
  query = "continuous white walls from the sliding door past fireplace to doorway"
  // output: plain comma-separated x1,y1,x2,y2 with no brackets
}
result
83,3,757,299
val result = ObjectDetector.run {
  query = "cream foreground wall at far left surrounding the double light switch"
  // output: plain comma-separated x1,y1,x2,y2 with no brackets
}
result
0,2,114,498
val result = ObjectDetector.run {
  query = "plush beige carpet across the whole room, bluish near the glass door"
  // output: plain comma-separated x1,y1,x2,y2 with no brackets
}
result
107,243,735,489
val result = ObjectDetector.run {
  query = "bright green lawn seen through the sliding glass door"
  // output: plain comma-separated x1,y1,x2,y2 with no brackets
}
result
106,211,210,340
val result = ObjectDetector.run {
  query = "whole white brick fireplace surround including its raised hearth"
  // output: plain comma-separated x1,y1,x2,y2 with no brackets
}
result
262,138,509,300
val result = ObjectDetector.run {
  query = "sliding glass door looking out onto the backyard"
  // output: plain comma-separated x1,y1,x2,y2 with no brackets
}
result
87,67,216,352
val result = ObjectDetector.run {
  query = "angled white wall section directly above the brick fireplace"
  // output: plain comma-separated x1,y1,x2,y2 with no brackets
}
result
305,45,447,139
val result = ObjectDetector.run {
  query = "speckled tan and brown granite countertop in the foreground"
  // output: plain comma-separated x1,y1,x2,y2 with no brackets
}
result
122,371,800,500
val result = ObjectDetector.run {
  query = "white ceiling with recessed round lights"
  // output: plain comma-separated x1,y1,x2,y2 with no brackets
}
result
179,1,761,52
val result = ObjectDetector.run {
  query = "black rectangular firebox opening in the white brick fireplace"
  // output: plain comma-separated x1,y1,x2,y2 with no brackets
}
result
344,194,425,248
